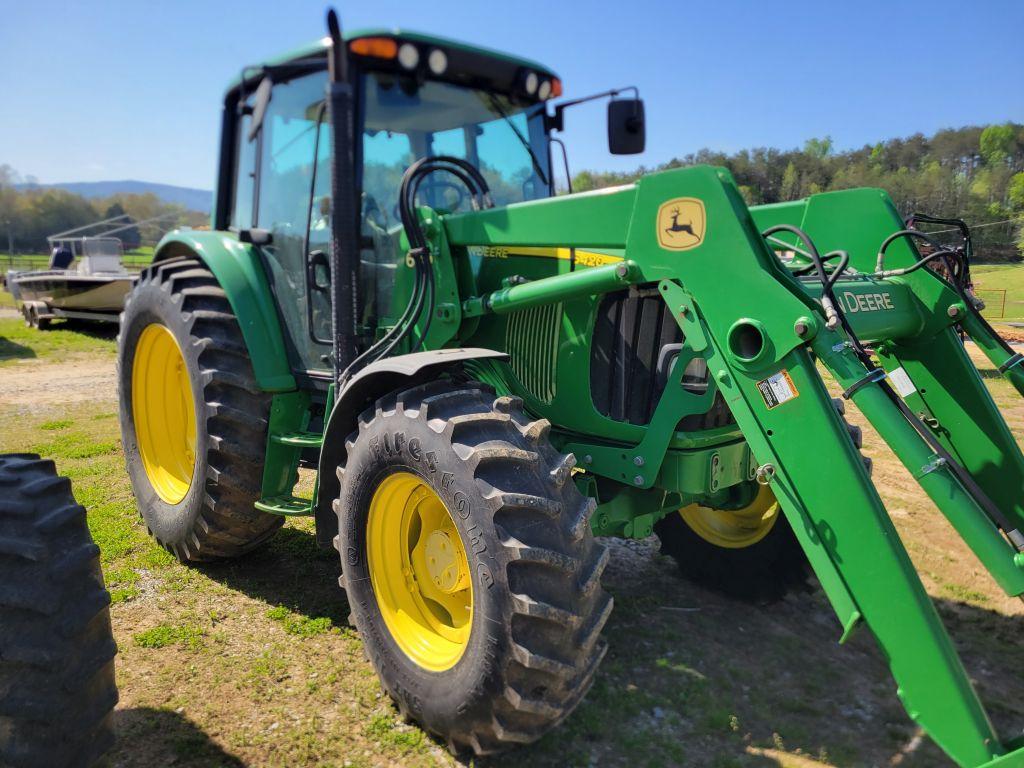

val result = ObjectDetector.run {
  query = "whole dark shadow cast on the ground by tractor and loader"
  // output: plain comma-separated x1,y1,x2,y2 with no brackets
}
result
193,525,1024,768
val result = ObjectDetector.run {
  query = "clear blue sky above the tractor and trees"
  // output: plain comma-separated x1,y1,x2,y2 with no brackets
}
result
0,0,1024,188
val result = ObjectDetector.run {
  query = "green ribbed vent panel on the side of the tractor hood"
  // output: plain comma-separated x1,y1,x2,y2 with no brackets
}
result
505,303,562,403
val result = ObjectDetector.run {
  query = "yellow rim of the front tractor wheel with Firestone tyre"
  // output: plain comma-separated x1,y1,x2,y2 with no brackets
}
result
367,472,473,672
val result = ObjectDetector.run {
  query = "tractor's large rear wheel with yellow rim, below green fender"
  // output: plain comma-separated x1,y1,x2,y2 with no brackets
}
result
118,258,283,562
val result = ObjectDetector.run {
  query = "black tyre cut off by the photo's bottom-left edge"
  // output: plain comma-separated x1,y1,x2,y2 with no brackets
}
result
0,454,118,768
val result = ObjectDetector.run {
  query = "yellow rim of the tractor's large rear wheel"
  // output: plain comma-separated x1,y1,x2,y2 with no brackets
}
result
131,324,196,504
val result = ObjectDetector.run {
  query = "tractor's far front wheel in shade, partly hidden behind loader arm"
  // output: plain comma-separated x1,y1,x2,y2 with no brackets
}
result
654,397,871,602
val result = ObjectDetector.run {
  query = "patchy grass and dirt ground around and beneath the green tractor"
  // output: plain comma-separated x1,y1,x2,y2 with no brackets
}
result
0,318,1024,768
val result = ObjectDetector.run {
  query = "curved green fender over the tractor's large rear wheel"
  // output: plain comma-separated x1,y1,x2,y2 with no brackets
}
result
153,229,296,392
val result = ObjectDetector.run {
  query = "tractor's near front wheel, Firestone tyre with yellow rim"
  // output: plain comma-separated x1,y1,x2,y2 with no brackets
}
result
335,381,611,755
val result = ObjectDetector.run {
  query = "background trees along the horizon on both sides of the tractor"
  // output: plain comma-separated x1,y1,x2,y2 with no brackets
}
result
6,123,1024,261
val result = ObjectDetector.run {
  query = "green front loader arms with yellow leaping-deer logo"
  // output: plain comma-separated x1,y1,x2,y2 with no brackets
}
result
443,167,1024,766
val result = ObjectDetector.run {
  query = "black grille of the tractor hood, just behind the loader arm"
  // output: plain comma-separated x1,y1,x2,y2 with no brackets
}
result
590,288,732,430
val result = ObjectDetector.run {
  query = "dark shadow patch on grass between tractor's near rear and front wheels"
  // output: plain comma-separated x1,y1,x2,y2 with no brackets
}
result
200,524,348,627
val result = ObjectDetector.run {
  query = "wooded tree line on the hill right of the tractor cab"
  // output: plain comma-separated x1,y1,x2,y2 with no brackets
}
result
572,123,1024,261
